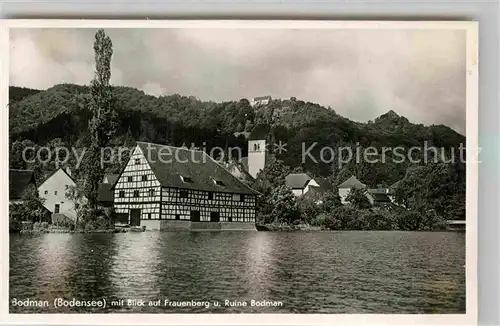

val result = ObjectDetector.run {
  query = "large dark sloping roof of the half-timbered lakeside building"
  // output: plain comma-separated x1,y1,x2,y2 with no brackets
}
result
131,142,258,194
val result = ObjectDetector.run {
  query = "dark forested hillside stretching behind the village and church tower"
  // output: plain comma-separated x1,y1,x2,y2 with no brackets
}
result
9,84,465,186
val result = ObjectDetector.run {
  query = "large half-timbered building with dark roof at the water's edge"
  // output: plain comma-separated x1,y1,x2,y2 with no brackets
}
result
112,142,257,230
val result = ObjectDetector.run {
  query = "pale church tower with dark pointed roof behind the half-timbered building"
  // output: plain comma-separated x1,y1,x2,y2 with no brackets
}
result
248,124,270,178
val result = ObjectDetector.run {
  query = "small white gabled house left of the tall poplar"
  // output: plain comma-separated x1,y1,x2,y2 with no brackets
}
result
38,168,82,220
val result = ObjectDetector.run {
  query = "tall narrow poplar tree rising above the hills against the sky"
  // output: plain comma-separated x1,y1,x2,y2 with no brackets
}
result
84,29,116,212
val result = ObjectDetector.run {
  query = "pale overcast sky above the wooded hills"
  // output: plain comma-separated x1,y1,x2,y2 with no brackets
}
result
10,29,466,133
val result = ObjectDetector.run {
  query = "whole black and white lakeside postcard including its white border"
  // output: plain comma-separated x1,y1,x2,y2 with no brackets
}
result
2,21,478,321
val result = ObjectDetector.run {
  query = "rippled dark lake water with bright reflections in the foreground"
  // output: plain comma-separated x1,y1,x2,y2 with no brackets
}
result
9,232,465,313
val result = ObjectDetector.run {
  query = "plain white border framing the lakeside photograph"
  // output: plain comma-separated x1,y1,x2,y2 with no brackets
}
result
0,19,478,325
